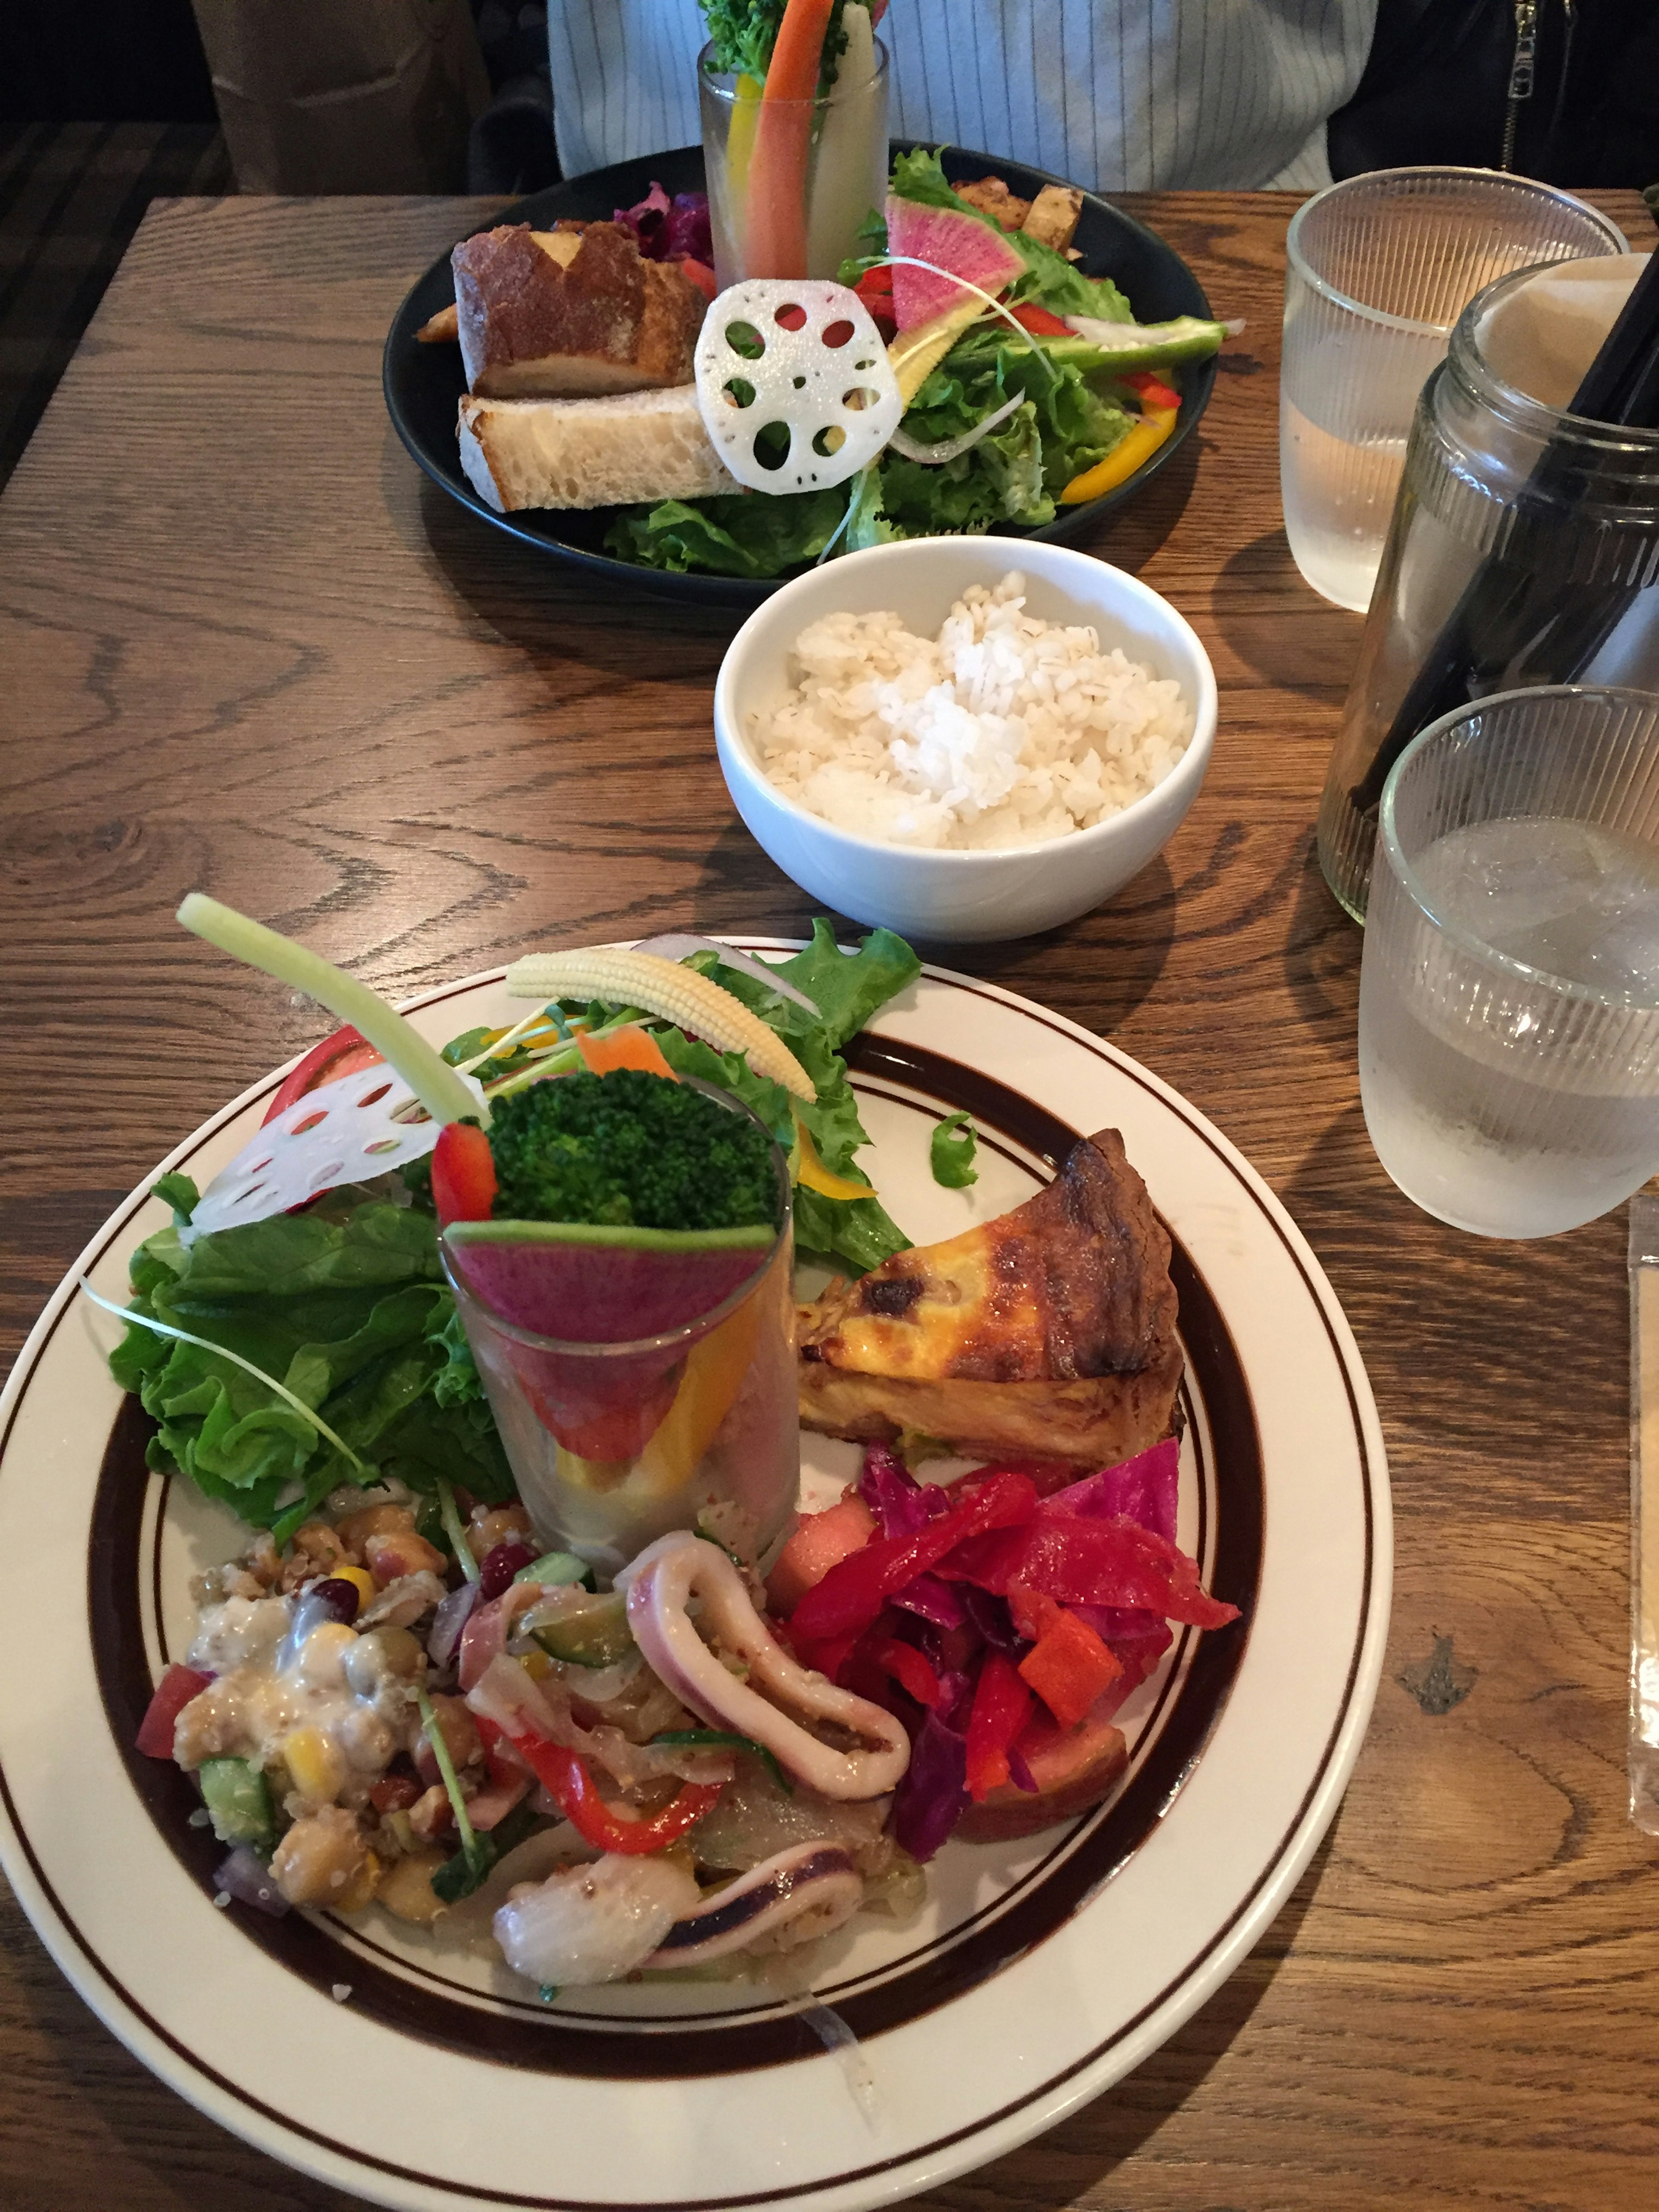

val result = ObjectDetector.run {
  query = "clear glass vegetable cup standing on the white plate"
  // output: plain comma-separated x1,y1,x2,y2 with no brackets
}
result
438,1084,801,1573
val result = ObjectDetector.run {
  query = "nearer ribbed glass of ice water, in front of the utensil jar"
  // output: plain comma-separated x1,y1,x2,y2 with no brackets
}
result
1360,686,1659,1236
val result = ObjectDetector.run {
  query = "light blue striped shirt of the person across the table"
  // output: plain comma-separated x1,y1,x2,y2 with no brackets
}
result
549,0,1378,192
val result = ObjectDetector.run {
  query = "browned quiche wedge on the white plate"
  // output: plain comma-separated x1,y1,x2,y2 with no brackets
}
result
796,1128,1181,1467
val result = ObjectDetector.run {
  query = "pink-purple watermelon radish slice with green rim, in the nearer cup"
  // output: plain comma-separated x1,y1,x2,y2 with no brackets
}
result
445,1221,776,1462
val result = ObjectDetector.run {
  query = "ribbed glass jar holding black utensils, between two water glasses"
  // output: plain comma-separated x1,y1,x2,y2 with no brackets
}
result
1319,270,1659,922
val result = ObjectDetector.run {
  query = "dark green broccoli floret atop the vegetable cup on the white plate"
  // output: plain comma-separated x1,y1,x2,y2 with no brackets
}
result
489,1068,776,1230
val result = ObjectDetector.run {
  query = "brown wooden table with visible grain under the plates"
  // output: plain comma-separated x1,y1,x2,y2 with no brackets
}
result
0,192,1659,2212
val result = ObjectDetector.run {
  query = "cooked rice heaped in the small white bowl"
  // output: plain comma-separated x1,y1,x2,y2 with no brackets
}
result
752,571,1192,849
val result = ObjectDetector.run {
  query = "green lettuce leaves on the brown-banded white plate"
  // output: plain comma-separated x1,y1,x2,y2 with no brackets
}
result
111,920,920,1542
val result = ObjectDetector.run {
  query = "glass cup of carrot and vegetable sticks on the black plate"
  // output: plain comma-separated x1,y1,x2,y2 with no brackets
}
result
697,40,887,288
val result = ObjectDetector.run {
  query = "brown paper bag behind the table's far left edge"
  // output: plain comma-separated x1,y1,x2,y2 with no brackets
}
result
192,0,489,192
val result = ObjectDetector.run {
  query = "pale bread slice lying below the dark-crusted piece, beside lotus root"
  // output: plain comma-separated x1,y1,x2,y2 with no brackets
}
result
458,385,743,515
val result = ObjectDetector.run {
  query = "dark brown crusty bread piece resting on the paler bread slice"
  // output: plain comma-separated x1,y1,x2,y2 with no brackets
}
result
451,223,706,398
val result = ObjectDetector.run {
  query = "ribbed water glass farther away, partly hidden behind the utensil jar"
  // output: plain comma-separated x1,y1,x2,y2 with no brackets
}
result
1278,168,1628,613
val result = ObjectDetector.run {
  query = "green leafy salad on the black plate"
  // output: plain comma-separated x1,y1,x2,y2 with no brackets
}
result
606,149,1194,577
